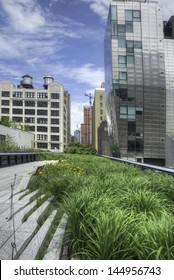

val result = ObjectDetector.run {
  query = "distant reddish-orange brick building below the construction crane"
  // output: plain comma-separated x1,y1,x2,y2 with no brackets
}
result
81,106,92,146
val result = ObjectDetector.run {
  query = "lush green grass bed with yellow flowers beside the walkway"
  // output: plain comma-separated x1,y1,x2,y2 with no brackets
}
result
30,154,174,260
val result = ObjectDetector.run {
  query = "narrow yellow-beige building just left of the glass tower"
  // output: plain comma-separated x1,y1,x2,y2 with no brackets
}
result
92,83,106,151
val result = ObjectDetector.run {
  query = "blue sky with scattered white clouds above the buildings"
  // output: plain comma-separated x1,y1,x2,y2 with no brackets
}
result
0,0,174,132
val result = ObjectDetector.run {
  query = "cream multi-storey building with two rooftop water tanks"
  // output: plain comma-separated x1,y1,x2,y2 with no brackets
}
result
0,74,70,152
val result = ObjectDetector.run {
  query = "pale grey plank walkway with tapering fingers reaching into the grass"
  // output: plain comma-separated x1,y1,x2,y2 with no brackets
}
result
0,162,66,260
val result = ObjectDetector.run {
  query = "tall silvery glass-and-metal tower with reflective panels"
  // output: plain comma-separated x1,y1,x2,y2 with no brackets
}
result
105,0,166,165
